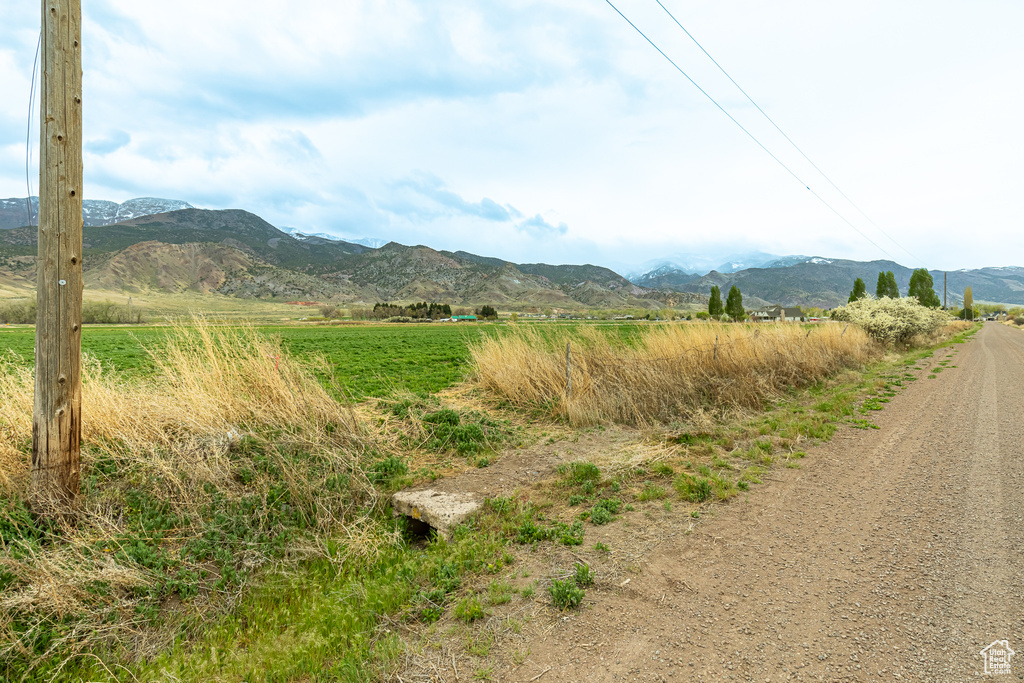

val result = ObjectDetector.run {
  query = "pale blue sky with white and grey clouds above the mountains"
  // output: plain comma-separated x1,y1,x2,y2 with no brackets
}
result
0,0,1024,270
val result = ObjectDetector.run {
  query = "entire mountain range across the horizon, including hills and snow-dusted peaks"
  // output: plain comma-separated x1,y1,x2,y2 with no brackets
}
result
0,198,1024,309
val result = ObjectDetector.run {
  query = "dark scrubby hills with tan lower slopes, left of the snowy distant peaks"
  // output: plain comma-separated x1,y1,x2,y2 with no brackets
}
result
0,208,702,309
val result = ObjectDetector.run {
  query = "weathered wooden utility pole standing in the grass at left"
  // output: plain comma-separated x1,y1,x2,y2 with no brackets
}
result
32,0,83,514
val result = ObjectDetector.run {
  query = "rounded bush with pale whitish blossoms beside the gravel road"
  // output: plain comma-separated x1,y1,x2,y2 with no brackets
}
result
831,296,951,346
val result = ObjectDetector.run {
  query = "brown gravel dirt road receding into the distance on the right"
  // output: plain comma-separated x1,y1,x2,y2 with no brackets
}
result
516,324,1024,683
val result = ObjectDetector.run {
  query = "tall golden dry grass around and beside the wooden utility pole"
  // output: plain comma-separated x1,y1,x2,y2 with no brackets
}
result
0,317,365,495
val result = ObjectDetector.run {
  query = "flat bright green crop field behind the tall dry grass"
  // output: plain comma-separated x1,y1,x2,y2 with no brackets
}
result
0,324,499,400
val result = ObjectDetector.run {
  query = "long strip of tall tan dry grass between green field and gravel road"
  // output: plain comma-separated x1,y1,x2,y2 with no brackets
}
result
471,324,881,425
